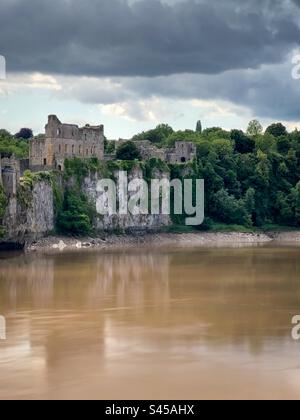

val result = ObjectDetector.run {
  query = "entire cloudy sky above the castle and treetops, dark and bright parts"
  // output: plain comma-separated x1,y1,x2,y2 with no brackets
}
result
0,0,300,138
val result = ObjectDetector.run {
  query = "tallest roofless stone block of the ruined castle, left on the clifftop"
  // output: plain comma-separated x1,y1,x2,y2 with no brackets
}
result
29,115,104,171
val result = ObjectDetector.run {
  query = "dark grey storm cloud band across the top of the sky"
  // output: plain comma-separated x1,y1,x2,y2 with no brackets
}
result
0,0,300,76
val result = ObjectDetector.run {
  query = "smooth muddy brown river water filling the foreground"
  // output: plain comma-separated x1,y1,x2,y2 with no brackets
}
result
0,246,300,399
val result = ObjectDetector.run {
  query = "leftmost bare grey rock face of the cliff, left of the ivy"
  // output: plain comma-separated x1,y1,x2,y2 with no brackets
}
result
0,181,54,245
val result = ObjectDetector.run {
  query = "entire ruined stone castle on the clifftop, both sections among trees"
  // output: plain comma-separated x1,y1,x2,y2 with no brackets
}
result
29,115,197,171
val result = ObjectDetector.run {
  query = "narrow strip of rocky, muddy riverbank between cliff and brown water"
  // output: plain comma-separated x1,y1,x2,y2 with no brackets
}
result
25,231,300,252
